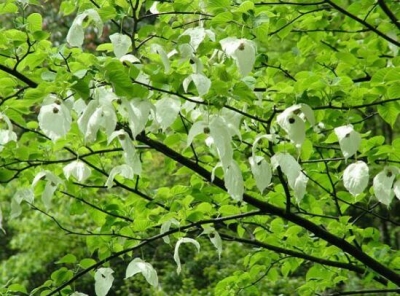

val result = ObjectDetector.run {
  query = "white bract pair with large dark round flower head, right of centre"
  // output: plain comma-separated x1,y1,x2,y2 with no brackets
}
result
277,104,315,148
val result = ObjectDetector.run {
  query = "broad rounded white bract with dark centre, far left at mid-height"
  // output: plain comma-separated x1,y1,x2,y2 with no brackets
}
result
38,95,72,142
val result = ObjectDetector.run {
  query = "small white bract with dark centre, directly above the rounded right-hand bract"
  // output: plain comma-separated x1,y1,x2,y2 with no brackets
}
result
335,124,361,160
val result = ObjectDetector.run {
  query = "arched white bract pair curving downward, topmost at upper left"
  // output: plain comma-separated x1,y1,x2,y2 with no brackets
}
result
67,9,103,47
